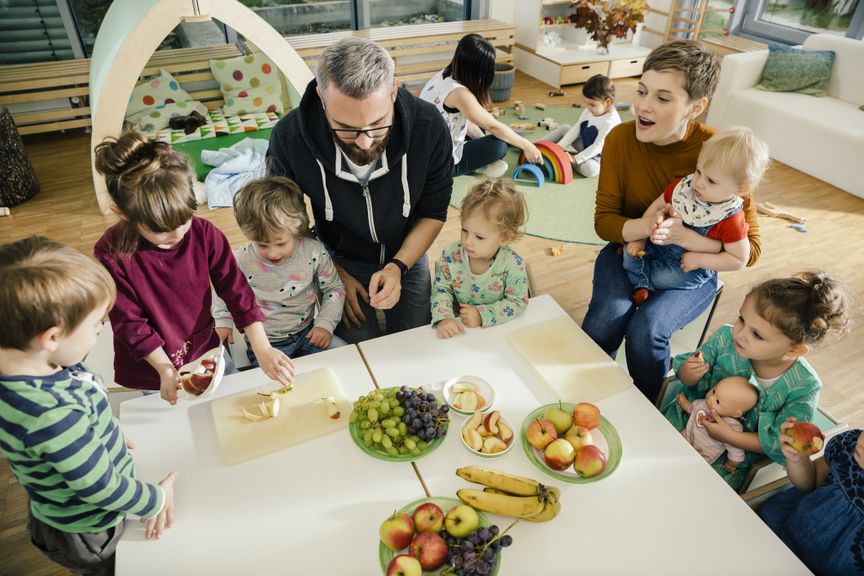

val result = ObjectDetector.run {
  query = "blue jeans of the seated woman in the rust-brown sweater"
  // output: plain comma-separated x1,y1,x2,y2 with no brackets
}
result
582,243,717,402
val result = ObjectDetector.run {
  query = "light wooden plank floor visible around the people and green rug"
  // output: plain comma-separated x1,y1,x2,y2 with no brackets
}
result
0,73,864,576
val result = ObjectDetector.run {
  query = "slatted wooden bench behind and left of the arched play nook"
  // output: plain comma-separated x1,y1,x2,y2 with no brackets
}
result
0,44,241,135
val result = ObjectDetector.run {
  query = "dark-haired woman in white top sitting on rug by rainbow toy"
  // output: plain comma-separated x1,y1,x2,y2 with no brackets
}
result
420,34,543,178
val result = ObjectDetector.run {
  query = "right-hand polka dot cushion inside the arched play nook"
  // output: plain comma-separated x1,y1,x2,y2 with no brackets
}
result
210,52,284,116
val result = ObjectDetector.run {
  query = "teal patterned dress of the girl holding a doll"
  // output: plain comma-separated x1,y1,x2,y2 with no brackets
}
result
663,325,822,490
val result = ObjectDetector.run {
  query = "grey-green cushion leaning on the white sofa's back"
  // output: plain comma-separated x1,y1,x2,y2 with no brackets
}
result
756,44,834,96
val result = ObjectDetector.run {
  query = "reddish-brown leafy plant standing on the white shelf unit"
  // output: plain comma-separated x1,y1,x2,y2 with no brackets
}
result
570,0,648,54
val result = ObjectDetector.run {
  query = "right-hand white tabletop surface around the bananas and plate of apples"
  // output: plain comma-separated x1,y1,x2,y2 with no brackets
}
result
360,296,809,576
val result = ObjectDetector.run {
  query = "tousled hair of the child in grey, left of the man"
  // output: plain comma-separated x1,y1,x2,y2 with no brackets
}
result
234,176,309,243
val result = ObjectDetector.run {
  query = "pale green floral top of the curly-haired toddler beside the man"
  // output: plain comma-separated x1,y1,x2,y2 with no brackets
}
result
432,242,528,327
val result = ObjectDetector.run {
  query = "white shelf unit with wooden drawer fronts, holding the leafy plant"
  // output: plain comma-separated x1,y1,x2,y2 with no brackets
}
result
513,0,651,88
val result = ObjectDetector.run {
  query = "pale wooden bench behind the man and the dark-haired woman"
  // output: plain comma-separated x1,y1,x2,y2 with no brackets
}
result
278,20,516,85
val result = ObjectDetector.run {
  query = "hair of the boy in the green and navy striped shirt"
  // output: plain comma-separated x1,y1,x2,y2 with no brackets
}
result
0,236,116,350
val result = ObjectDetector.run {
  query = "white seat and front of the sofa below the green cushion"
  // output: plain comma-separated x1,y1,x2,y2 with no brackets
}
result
724,88,864,197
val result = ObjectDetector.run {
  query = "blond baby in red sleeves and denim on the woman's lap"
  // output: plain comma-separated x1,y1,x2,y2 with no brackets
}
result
623,126,769,306
